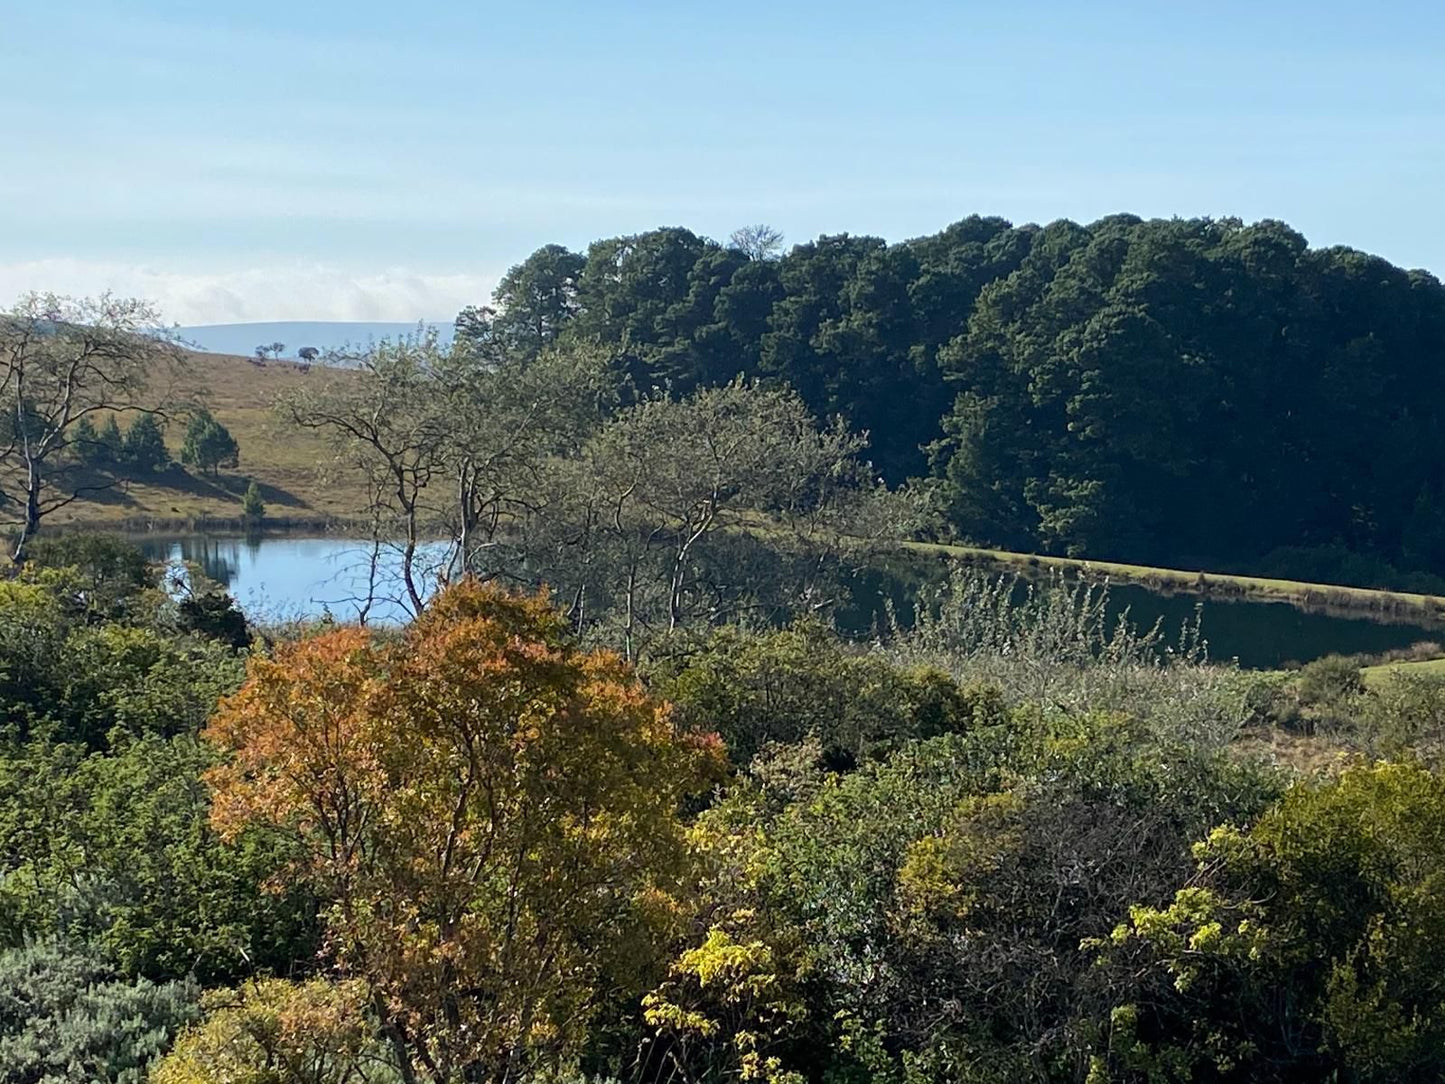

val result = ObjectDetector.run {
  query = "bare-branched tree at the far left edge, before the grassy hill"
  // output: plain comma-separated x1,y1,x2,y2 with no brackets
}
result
0,293,185,564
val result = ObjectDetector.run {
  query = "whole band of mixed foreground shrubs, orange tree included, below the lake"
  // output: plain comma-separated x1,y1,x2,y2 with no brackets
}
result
0,536,1445,1084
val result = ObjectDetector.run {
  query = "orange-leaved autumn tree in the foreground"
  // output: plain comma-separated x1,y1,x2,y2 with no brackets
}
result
207,581,723,1083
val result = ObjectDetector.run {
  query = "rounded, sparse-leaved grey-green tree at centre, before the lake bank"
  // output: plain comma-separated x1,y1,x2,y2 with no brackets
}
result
517,382,900,656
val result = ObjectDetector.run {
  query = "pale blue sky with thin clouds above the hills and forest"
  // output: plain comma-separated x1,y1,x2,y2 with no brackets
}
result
0,0,1445,324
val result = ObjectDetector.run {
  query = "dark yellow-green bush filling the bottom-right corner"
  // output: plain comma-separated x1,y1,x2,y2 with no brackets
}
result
1094,763,1445,1084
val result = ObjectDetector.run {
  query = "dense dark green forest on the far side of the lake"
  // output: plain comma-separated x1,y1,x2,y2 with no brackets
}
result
458,215,1445,581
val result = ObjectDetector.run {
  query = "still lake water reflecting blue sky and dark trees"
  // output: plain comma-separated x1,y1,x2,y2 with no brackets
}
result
136,535,1445,669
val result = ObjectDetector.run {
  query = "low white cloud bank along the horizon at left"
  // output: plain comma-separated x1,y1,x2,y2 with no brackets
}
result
0,259,499,324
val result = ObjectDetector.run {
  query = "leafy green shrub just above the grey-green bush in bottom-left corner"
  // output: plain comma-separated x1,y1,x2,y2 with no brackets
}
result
0,737,315,980
